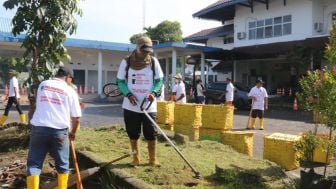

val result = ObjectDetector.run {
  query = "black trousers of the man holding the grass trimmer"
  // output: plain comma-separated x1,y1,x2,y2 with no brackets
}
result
124,109,157,140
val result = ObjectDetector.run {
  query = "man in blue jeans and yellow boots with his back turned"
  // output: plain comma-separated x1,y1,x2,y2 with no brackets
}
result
27,67,82,189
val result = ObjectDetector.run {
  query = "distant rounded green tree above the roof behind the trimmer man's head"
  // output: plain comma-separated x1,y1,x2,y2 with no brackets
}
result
130,20,183,44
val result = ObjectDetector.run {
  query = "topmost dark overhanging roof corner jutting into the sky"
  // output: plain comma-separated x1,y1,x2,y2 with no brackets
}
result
193,0,248,21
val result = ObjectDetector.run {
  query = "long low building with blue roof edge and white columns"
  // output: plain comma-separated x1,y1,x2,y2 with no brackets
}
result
0,18,219,97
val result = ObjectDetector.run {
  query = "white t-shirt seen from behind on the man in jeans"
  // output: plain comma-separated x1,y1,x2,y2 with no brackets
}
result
31,78,82,129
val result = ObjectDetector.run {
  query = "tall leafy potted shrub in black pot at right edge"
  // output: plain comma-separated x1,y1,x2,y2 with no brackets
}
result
297,25,336,189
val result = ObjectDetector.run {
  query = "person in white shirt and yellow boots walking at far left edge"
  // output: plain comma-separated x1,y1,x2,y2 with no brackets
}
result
0,70,26,126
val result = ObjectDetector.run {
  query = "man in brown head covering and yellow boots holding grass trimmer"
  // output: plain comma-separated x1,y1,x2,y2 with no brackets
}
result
117,37,163,166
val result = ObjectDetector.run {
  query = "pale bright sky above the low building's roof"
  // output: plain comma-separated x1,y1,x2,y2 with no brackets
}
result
0,0,221,43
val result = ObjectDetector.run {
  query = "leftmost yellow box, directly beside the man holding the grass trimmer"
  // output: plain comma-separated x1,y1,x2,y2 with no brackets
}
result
156,101,175,125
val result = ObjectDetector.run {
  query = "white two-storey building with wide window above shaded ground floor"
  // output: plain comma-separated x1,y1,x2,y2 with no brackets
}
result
185,0,336,94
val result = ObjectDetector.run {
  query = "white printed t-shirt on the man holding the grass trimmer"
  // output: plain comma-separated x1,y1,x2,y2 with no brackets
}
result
117,57,163,113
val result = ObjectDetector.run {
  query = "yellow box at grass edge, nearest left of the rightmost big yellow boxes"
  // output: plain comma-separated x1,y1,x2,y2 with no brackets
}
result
221,131,254,157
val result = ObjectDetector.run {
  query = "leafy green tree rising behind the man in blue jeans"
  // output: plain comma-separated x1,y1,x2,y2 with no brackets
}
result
3,0,82,118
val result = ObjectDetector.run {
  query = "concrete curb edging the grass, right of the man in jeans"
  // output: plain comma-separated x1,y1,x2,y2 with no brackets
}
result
76,151,153,189
